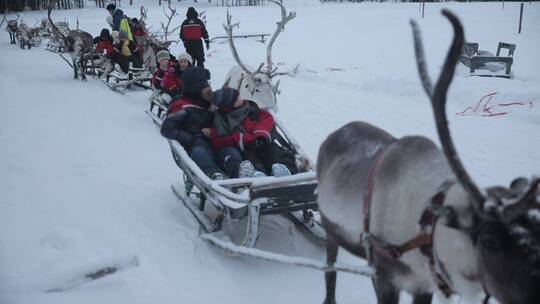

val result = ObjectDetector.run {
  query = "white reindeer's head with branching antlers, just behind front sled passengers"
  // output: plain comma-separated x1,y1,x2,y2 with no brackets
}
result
223,0,298,110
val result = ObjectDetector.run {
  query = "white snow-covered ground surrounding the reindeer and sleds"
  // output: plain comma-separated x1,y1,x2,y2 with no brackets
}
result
0,0,540,304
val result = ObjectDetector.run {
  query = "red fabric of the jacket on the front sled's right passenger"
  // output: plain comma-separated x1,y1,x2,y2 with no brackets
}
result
210,110,275,151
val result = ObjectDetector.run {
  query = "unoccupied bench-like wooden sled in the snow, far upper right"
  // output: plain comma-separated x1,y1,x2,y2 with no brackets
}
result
461,42,516,78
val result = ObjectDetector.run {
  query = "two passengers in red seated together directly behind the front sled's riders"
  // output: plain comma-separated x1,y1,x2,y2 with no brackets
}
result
152,50,192,104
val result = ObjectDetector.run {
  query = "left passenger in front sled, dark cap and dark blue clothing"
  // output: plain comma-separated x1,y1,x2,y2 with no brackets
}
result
161,67,238,180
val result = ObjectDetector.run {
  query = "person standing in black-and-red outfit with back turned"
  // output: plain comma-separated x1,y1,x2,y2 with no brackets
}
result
180,7,210,67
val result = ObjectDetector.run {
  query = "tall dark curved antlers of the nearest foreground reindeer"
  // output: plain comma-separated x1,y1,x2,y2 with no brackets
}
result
411,10,485,214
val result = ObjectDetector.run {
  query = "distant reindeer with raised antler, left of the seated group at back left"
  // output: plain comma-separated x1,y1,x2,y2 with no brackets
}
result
47,5,94,80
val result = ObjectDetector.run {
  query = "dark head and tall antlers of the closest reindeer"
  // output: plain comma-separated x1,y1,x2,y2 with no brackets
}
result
411,10,540,303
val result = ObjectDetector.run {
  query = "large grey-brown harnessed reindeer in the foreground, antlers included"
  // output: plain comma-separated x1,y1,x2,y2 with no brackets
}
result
317,10,540,304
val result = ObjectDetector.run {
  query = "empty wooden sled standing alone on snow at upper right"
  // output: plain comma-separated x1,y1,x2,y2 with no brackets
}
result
460,42,516,78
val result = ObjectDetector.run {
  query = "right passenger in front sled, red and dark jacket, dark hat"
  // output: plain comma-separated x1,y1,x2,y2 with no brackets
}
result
203,88,297,177
